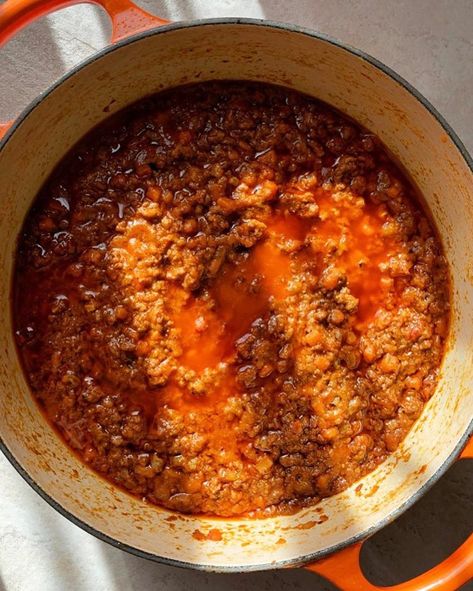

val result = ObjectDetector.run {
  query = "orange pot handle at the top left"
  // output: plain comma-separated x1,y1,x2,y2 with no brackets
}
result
0,0,169,139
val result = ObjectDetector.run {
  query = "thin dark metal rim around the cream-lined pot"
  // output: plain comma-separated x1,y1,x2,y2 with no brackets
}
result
0,17,473,573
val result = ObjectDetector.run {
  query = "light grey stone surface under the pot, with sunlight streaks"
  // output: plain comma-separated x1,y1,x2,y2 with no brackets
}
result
0,0,473,591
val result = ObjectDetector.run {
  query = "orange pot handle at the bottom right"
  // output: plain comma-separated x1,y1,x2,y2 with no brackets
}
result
305,437,473,591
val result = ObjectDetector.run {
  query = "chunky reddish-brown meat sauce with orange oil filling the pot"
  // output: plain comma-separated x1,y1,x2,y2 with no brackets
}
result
14,82,449,516
